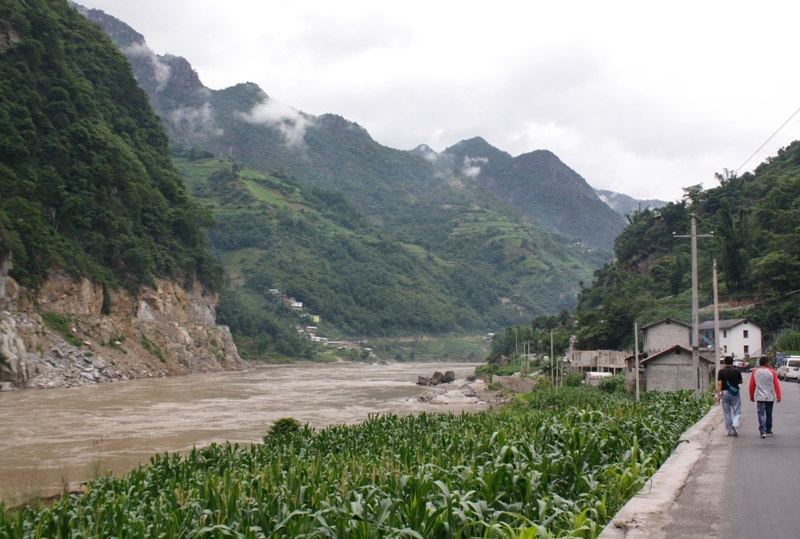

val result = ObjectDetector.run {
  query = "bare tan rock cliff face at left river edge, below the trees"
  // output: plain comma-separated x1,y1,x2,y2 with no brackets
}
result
0,270,246,390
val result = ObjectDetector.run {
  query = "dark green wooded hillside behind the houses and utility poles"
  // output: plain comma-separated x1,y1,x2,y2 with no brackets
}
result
577,142,800,349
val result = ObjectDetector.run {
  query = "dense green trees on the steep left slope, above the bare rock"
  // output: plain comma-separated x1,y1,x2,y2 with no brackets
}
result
0,0,221,287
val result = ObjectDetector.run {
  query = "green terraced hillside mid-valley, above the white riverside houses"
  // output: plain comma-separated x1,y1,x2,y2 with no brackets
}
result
175,159,536,338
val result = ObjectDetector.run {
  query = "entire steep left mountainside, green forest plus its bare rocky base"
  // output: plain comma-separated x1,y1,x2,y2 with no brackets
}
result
0,0,248,390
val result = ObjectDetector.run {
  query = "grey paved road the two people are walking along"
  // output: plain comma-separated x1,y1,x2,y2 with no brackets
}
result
657,375,800,539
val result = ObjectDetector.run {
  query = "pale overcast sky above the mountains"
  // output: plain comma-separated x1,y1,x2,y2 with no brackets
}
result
79,0,800,200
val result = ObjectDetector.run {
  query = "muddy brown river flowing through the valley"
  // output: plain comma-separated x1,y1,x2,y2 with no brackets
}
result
0,363,486,499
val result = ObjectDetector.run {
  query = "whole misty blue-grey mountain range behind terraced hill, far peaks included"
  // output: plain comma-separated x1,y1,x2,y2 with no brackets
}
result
75,5,622,319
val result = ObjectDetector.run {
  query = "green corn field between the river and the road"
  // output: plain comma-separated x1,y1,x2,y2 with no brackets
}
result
0,388,710,539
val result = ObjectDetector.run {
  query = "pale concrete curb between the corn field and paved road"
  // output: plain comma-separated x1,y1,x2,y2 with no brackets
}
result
598,406,722,539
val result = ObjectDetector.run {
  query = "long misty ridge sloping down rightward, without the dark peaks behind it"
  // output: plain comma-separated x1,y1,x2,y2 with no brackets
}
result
75,3,608,317
